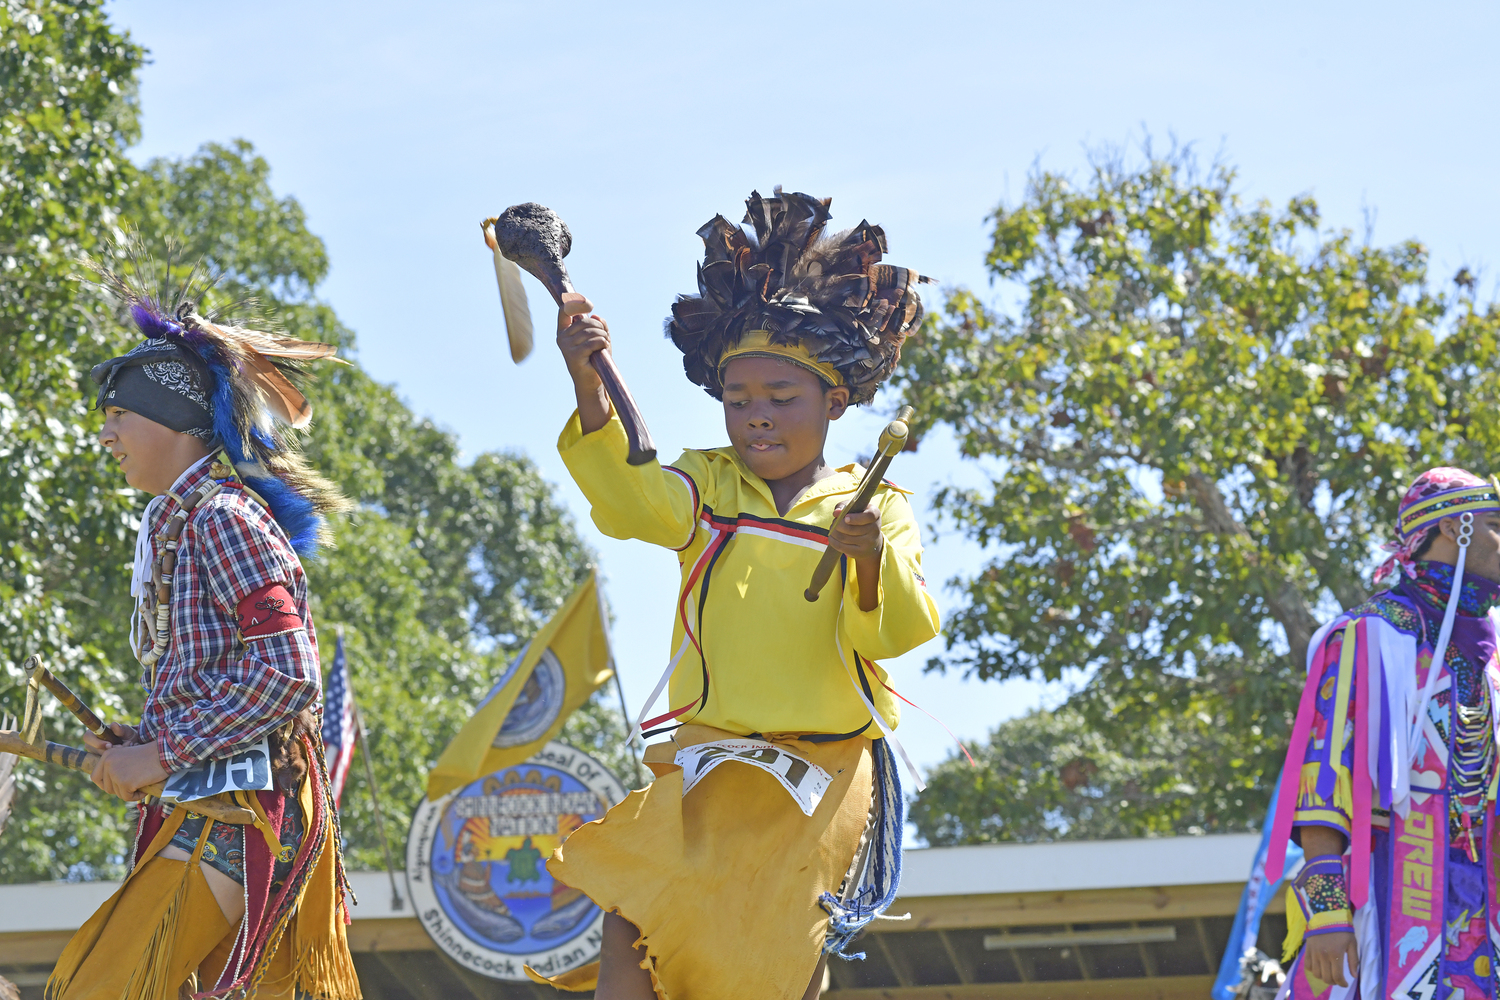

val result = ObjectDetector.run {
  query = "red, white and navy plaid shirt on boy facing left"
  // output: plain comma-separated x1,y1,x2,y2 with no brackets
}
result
141,463,321,771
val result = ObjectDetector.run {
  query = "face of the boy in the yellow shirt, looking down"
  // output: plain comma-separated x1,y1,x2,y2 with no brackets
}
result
725,357,849,483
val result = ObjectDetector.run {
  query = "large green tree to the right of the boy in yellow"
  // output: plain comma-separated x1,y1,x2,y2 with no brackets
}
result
897,146,1500,831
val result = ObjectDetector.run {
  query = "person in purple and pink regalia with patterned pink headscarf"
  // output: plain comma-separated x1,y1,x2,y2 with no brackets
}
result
1266,468,1500,1000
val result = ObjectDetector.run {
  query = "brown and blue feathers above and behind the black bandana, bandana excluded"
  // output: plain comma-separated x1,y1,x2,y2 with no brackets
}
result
84,244,350,558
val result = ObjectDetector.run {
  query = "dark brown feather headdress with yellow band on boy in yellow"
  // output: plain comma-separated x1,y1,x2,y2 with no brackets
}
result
666,187,932,403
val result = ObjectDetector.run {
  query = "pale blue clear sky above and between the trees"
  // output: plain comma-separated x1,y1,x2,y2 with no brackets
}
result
110,0,1500,779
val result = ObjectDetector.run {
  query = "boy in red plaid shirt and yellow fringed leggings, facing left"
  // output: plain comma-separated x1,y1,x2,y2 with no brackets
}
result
47,259,360,1000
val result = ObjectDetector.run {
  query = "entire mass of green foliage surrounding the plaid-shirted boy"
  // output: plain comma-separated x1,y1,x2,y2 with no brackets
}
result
0,1,615,882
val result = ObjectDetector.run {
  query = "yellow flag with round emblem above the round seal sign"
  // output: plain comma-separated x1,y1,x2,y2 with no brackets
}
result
428,573,614,801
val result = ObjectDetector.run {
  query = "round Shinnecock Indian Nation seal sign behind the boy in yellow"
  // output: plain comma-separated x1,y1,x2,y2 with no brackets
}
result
407,741,626,982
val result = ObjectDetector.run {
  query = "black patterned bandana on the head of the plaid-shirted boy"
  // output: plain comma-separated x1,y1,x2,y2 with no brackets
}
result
89,340,215,441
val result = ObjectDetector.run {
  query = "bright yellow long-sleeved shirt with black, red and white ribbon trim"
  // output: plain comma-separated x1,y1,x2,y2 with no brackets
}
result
558,412,941,738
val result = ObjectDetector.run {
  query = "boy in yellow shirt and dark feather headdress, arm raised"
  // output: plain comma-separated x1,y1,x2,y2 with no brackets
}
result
533,190,939,1000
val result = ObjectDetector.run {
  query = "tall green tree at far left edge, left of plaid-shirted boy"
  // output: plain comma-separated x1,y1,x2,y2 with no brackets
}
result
0,0,143,879
